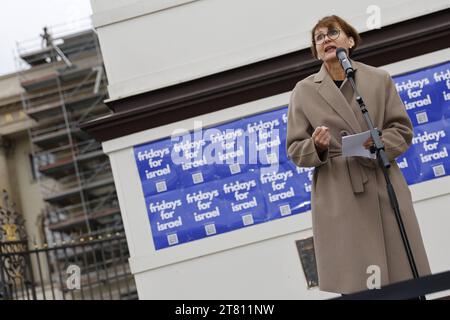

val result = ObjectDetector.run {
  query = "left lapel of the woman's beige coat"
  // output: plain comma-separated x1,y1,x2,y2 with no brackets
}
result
314,63,361,133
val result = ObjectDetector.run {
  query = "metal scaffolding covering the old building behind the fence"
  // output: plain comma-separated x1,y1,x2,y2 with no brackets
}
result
17,21,123,242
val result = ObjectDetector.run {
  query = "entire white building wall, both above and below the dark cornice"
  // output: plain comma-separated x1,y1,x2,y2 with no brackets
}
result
91,0,450,299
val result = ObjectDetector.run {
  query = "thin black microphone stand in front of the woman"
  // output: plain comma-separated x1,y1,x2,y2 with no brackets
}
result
344,69,426,300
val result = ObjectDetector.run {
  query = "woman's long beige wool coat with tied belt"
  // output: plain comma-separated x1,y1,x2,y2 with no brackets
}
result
286,61,431,294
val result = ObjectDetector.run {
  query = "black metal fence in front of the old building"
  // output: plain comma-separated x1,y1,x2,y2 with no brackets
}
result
0,234,137,300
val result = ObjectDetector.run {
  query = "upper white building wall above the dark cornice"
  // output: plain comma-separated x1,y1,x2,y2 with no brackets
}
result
91,0,449,100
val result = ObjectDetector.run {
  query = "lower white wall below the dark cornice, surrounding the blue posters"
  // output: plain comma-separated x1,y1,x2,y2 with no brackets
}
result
103,49,450,299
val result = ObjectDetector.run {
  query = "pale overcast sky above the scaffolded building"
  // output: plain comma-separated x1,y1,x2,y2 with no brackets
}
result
0,0,92,75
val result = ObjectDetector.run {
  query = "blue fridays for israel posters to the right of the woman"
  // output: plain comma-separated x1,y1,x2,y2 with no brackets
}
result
393,62,450,185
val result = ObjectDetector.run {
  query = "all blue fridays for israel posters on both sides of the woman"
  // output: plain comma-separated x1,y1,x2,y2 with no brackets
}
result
134,62,450,250
